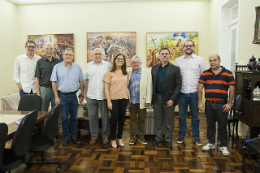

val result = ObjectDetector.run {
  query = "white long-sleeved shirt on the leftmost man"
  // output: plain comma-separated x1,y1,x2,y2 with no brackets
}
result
13,54,41,93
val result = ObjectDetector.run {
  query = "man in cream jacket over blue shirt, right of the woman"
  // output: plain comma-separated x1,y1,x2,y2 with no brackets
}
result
128,55,153,145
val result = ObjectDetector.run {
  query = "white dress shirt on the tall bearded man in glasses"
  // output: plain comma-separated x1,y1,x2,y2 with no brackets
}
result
174,54,206,94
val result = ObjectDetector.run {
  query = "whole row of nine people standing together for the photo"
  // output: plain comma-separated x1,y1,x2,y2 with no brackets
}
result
13,40,235,155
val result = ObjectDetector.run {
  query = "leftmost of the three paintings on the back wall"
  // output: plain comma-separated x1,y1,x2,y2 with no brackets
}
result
28,34,75,61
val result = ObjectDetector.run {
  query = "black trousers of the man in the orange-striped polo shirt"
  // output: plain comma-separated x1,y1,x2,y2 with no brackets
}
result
205,101,228,147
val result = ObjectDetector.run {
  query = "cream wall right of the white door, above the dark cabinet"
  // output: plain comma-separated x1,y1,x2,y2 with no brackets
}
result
238,0,260,63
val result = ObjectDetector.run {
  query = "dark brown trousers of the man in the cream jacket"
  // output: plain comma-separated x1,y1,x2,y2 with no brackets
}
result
129,103,146,139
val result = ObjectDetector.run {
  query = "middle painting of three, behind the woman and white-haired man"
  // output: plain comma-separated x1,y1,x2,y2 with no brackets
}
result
87,32,136,66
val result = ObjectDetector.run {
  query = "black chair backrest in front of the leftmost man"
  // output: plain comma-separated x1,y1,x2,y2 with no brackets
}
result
18,94,42,111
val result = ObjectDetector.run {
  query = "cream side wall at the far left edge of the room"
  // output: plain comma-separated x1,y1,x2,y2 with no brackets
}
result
0,0,19,97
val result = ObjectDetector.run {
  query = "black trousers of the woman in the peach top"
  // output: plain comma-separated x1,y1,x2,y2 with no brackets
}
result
110,99,128,140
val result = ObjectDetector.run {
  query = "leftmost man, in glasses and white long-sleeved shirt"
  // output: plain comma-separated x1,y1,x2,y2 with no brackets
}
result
13,39,41,98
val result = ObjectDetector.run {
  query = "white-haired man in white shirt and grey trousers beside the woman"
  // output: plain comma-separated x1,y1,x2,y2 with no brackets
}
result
84,48,112,145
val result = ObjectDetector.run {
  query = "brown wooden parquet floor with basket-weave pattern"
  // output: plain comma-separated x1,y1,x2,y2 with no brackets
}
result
12,114,257,173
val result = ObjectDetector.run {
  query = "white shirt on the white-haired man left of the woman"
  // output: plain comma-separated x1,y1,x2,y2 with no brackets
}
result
84,60,112,100
